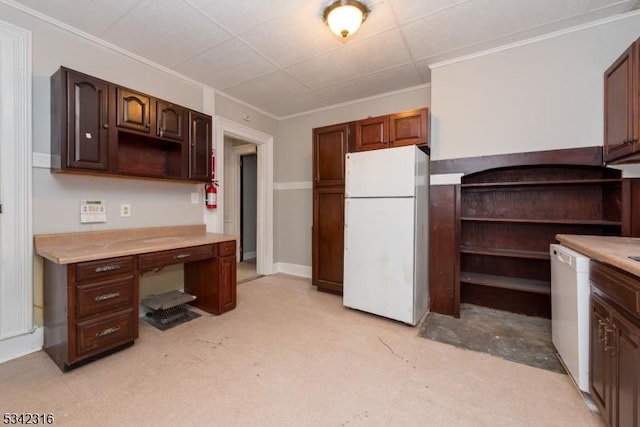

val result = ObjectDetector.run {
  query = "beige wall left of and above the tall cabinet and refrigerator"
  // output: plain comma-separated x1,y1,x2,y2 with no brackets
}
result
274,86,430,268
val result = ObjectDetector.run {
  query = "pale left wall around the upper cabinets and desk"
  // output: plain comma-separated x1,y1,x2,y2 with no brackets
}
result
0,4,208,325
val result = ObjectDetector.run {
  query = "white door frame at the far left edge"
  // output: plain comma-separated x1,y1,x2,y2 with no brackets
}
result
0,21,34,362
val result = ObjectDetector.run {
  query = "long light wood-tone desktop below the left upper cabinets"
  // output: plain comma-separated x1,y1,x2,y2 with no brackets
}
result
34,224,237,264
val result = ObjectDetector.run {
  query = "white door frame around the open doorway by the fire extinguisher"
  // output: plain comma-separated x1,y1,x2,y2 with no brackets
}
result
214,116,274,275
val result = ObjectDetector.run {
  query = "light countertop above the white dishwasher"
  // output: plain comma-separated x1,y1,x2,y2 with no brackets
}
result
556,234,640,277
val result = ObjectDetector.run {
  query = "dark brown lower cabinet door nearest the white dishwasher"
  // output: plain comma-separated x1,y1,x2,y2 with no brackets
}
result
589,295,613,420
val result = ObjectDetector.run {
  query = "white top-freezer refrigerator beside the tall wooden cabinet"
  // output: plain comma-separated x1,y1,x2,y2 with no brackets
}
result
343,145,429,325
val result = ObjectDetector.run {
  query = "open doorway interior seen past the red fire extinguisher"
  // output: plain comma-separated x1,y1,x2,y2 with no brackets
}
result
223,136,260,283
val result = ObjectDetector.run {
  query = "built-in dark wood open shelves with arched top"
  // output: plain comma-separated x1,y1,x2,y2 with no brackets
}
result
459,165,622,317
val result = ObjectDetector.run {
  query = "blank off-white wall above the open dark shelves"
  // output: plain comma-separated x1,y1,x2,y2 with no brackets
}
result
431,12,640,164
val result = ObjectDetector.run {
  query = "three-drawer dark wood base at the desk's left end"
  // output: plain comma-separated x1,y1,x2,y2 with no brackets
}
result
44,256,138,370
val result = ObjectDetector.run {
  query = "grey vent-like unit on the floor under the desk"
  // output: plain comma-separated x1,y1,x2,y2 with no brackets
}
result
141,291,200,331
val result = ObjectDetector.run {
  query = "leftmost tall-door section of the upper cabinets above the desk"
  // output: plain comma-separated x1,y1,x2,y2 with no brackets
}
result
51,69,110,171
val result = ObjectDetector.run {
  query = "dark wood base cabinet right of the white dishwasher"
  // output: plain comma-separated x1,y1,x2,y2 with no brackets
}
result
589,261,640,427
